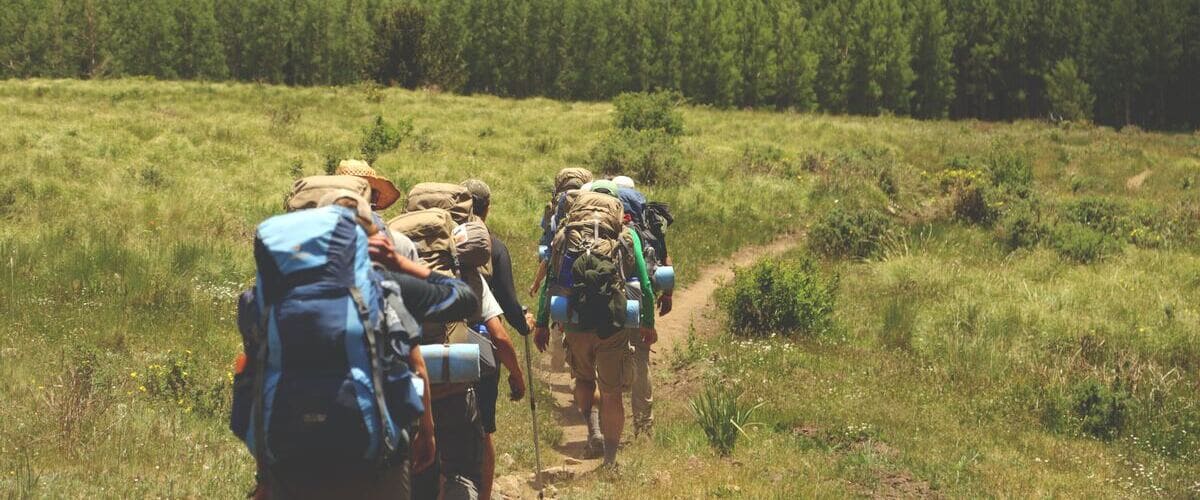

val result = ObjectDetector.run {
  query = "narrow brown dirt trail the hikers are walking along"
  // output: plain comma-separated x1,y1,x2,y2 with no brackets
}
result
494,235,800,499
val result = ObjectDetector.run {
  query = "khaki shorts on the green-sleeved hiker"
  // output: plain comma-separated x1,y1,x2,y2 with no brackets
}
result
563,330,635,393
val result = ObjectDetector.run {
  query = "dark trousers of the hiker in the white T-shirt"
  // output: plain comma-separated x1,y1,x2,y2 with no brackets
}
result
413,388,484,500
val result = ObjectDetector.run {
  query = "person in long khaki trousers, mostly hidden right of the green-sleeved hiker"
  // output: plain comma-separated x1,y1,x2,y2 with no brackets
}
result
612,175,673,436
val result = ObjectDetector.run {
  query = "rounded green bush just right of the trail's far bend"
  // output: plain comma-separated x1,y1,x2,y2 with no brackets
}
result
809,209,893,259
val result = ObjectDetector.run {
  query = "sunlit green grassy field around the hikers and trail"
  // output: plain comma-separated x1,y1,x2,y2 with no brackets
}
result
0,80,1200,498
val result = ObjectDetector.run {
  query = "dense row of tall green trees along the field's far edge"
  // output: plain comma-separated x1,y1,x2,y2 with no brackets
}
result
0,0,1200,128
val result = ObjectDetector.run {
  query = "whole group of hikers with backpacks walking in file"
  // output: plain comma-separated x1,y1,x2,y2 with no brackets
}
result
230,159,674,499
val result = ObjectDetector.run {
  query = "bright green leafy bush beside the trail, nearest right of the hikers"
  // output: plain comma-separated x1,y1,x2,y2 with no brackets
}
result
719,258,838,337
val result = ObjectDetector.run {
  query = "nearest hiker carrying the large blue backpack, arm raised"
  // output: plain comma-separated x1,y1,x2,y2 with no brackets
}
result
230,188,479,499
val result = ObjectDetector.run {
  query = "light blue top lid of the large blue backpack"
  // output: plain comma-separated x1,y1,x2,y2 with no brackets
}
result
254,205,370,302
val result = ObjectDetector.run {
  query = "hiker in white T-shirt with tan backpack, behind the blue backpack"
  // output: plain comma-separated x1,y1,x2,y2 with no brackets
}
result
389,183,526,499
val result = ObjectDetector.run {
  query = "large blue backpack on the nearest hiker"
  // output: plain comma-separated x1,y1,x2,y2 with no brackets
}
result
230,205,424,466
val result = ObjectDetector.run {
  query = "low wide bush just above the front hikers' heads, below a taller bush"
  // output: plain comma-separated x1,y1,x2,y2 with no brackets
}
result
590,129,688,185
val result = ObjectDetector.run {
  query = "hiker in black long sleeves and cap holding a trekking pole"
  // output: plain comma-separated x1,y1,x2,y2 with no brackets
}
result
462,179,533,499
